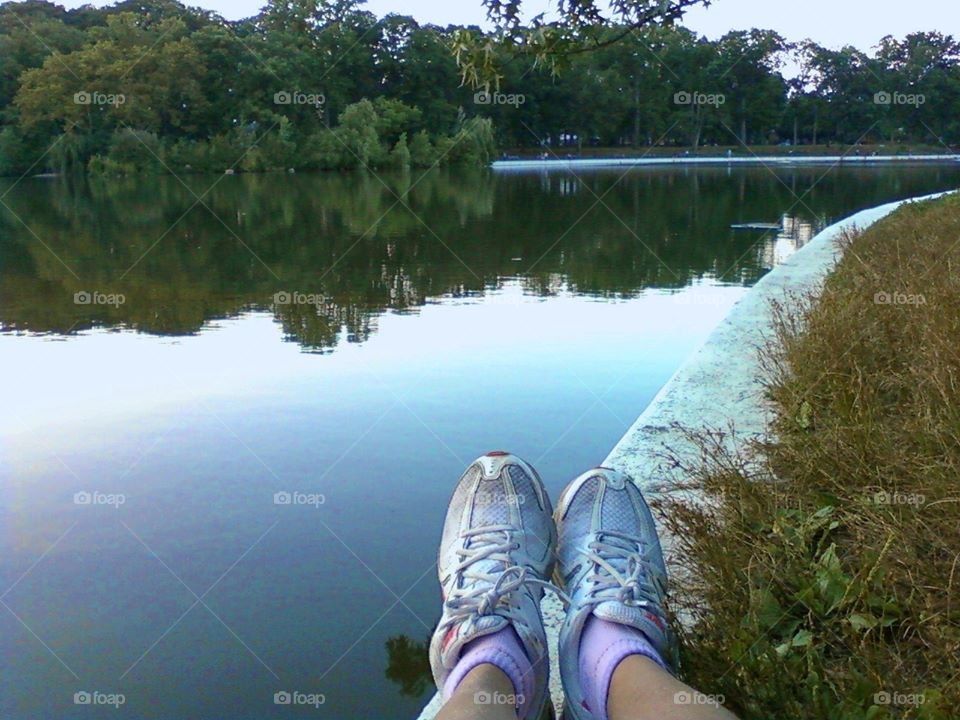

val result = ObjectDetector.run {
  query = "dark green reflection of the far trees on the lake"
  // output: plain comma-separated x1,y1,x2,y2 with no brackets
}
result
0,166,960,352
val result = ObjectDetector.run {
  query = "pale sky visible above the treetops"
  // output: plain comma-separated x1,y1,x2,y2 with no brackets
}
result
56,0,960,50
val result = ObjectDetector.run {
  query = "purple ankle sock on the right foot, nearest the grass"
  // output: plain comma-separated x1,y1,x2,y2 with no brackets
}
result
580,616,667,720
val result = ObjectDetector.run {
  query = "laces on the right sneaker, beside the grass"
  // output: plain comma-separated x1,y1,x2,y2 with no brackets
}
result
580,531,666,617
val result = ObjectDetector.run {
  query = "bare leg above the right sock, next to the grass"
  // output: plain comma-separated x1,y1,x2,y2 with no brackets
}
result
612,655,736,720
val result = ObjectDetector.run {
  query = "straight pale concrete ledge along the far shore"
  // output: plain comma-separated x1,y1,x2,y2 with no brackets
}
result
491,155,960,171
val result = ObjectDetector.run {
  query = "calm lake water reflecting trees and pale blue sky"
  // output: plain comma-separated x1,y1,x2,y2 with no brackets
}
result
0,165,960,720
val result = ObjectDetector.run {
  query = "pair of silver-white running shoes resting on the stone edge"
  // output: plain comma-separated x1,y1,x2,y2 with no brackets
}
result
430,451,676,720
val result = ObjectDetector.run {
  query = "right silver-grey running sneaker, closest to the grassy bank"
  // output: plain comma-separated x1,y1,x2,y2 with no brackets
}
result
555,468,676,720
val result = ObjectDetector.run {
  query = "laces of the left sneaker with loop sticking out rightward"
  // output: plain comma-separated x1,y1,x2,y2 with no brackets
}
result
443,525,569,626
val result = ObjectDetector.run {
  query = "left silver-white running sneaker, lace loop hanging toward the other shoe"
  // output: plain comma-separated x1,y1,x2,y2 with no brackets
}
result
430,451,557,718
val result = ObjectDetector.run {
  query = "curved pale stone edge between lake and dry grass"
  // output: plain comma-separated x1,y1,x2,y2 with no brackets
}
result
419,190,960,720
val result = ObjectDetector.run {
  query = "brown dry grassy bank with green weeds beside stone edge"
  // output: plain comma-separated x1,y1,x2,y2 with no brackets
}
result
663,197,960,720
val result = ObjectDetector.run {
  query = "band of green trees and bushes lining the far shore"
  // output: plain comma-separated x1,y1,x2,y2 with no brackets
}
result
0,0,960,177
